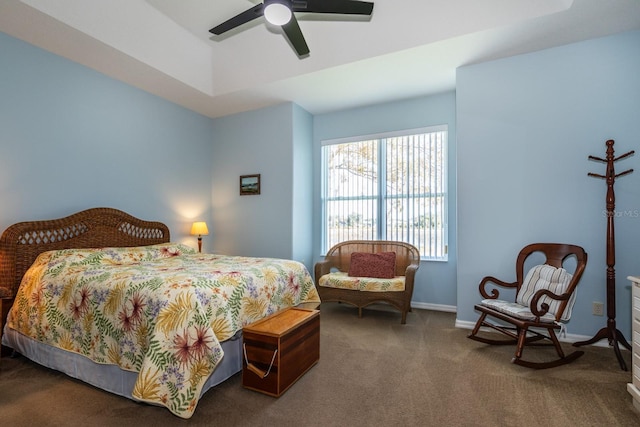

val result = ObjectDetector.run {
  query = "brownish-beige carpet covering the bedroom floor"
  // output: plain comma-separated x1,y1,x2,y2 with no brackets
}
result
0,304,640,427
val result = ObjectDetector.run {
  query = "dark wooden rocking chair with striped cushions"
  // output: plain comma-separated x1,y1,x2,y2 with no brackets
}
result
468,243,587,369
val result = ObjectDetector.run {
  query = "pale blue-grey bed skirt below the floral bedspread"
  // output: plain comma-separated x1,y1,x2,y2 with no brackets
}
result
2,327,242,400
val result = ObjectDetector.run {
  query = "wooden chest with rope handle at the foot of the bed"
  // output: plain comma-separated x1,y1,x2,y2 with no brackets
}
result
242,307,320,397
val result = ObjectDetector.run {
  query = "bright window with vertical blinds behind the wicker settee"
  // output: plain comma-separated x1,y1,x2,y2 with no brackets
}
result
322,126,448,260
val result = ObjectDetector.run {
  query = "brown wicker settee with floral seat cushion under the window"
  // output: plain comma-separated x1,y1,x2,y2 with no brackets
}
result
314,240,420,324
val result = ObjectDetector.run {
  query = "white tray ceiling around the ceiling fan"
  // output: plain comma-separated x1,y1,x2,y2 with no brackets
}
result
0,0,640,117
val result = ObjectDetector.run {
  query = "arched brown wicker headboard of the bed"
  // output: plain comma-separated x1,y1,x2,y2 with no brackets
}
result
0,208,170,297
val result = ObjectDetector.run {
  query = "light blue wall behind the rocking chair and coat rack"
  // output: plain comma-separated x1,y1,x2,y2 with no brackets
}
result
457,32,640,338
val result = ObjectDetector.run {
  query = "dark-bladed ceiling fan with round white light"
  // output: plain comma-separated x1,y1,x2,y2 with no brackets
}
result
209,0,373,56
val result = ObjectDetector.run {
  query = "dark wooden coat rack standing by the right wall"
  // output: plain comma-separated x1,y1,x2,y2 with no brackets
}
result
573,139,634,371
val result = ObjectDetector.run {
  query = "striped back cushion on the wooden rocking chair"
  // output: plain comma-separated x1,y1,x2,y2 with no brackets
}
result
516,264,576,321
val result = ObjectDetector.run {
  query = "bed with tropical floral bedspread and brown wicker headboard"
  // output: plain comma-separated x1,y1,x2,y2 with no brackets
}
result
0,208,320,418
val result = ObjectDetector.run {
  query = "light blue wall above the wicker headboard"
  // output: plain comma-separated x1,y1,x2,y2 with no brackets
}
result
0,33,213,246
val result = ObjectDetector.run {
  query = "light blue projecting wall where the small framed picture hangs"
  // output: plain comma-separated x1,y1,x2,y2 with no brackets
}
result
212,103,313,269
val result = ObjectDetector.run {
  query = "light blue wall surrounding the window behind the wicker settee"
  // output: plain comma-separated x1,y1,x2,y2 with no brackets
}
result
313,92,457,307
